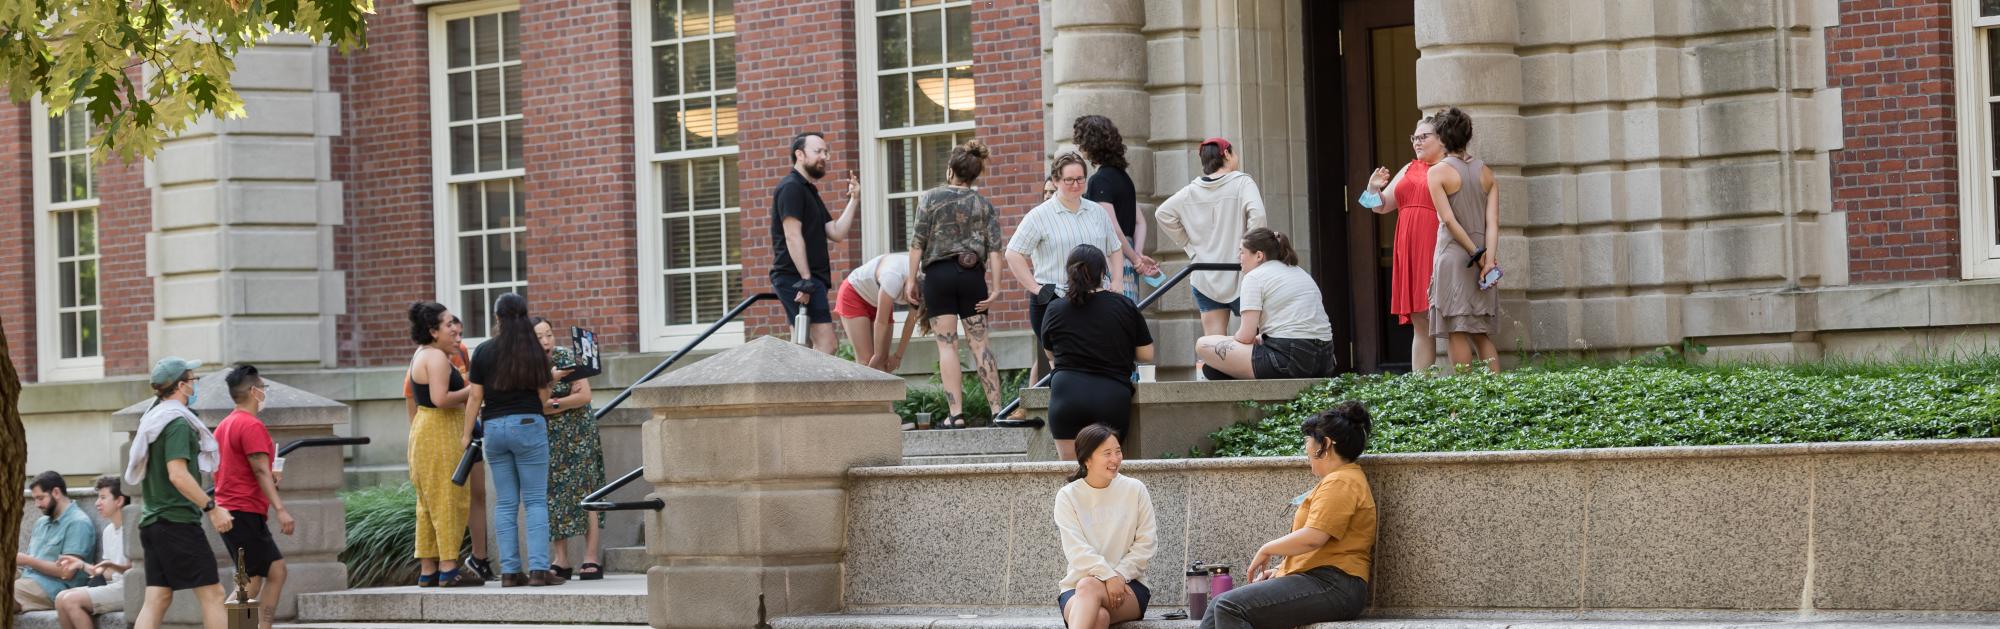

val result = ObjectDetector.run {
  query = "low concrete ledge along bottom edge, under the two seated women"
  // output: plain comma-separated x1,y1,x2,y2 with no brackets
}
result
772,605,1996,629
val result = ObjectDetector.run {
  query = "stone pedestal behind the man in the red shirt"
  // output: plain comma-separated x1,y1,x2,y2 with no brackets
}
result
112,371,348,627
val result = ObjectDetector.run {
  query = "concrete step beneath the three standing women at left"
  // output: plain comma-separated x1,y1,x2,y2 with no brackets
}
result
298,575,646,627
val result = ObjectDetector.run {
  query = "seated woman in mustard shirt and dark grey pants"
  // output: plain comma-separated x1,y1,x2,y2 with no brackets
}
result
1202,403,1376,629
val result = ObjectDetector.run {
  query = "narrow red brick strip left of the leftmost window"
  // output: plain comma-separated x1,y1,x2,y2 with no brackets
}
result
0,102,36,383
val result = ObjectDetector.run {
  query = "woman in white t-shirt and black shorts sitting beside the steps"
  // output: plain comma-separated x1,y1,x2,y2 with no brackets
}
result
1194,226,1334,381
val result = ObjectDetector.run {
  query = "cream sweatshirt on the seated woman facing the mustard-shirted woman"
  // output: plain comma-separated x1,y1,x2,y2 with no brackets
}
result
1056,475,1158,589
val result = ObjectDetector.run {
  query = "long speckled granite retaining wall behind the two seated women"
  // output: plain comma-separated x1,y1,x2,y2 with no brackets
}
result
844,439,2000,613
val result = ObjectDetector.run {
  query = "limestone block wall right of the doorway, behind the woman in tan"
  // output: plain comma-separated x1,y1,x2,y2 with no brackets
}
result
1416,0,1846,355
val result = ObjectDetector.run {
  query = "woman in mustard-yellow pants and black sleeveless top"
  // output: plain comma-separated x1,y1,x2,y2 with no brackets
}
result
408,300,486,587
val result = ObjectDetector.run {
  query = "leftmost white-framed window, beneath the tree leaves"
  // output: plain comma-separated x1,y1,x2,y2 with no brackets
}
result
34,104,104,381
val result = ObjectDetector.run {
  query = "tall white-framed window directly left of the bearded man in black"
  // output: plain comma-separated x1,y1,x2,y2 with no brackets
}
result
634,0,742,339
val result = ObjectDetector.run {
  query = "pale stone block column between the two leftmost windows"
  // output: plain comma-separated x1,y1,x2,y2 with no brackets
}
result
146,34,346,367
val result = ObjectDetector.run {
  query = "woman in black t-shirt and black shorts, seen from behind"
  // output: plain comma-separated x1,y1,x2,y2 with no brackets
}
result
1042,244,1152,459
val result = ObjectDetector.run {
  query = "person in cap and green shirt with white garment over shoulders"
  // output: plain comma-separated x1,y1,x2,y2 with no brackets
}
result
126,357,234,629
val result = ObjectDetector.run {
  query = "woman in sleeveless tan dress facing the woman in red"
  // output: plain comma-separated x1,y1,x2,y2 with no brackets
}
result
1428,106,1500,373
